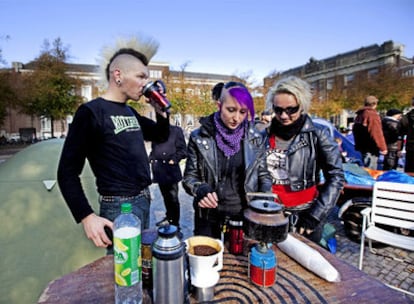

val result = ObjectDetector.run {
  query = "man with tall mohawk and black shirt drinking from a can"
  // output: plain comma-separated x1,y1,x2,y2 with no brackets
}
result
57,37,169,254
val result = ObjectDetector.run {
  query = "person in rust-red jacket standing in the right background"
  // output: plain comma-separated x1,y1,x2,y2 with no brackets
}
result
352,95,388,170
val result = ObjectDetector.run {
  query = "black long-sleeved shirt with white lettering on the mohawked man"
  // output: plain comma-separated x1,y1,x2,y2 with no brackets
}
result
58,98,169,222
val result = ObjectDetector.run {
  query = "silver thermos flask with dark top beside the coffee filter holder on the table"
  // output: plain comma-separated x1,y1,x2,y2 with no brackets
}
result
152,225,187,304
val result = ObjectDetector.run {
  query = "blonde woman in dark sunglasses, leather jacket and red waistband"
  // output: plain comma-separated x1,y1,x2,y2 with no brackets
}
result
266,76,345,243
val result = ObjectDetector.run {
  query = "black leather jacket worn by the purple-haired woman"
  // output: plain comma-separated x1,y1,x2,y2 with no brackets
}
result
182,116,272,203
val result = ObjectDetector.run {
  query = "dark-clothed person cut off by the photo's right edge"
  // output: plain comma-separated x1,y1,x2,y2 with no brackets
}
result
399,97,414,173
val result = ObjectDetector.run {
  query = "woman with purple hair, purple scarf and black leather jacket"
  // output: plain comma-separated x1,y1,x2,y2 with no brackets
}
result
183,82,272,238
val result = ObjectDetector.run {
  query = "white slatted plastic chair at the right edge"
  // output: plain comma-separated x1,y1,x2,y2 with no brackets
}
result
359,181,414,295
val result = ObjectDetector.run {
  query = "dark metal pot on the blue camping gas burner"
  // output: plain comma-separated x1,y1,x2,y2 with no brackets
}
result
243,193,289,243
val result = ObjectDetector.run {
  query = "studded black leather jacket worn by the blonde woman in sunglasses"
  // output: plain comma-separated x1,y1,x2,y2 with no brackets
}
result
267,117,345,221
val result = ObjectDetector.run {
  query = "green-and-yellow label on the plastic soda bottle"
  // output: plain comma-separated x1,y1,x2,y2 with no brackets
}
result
114,227,142,286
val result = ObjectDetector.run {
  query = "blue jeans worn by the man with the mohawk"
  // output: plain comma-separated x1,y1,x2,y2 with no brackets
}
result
99,188,151,254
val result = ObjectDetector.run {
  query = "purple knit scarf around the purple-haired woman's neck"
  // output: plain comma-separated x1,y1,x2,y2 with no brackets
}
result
214,112,247,157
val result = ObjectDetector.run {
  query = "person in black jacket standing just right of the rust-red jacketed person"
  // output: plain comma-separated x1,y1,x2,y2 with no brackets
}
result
382,109,402,170
